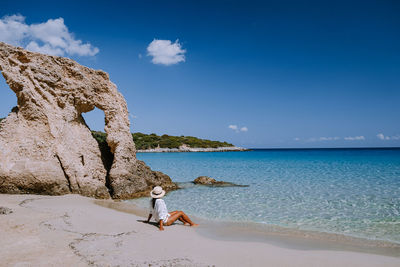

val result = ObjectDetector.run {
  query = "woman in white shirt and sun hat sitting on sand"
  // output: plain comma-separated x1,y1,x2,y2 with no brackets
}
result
147,186,198,231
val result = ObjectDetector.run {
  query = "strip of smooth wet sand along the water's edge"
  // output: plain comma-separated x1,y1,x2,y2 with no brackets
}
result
115,200,400,257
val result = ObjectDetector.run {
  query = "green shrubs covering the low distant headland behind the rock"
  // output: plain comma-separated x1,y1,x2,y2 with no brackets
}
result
92,131,233,149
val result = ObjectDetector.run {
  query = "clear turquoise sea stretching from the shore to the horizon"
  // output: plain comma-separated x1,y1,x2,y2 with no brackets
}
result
132,149,400,243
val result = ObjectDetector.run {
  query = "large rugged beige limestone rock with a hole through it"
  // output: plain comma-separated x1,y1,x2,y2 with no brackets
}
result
0,42,175,198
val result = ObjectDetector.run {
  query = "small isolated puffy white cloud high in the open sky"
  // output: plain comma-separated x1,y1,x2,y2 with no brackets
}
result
147,39,186,66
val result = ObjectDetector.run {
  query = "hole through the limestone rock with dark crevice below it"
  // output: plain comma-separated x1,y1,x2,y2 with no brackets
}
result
82,108,114,193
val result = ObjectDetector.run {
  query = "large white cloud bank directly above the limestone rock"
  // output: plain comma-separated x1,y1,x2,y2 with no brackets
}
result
0,15,99,56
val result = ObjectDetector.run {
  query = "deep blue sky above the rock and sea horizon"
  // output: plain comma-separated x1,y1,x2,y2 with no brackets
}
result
0,0,400,148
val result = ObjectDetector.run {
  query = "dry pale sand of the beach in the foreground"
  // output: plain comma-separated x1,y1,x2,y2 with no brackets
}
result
0,194,400,266
